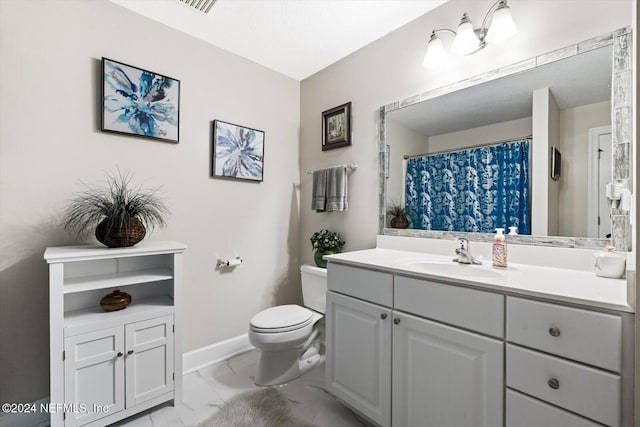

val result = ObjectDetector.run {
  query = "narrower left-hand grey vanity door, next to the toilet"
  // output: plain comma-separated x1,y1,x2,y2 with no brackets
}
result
326,292,392,427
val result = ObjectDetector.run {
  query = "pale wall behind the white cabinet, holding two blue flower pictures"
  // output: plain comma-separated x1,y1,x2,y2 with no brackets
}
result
0,0,300,402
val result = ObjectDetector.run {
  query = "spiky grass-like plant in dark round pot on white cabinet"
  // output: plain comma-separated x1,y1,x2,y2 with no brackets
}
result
64,171,168,248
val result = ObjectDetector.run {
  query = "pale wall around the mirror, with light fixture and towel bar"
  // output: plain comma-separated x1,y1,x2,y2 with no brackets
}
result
300,0,631,268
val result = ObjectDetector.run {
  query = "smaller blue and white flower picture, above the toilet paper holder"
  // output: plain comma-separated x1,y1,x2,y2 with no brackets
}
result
211,120,264,182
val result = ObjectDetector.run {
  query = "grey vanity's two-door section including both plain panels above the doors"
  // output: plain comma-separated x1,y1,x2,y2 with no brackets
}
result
326,263,504,427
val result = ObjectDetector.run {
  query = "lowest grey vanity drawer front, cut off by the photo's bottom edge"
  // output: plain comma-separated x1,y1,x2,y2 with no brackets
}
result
506,389,601,427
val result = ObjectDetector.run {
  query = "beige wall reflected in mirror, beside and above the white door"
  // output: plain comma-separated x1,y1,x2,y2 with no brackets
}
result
559,101,611,237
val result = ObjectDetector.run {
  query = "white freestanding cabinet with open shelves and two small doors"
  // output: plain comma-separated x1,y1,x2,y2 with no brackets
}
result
45,242,185,427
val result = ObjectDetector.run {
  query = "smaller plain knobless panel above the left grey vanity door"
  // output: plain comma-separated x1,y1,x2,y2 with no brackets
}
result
327,261,393,307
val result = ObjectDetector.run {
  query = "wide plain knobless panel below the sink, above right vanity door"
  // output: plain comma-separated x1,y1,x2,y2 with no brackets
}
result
393,276,504,338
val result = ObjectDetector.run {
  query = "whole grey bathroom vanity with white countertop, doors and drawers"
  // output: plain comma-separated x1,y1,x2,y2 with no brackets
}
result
326,248,634,427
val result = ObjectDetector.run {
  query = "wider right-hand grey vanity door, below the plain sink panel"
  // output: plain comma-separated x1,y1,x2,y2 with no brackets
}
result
392,312,504,427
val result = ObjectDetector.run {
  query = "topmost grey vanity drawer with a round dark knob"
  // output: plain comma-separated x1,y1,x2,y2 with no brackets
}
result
507,297,622,372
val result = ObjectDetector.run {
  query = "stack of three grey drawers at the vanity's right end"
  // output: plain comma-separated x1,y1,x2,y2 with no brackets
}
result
506,297,632,427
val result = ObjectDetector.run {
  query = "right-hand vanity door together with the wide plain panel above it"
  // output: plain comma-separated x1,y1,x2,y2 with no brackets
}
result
391,275,504,427
